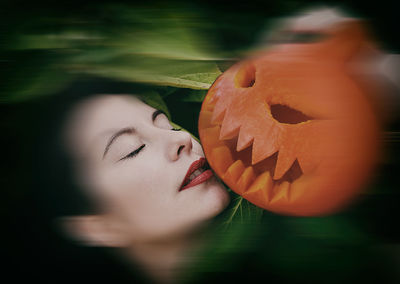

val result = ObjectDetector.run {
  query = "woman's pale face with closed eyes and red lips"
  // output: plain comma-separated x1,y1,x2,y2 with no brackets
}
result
66,95,229,242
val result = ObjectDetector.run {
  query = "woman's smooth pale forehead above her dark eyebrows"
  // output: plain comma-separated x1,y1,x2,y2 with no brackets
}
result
66,95,155,156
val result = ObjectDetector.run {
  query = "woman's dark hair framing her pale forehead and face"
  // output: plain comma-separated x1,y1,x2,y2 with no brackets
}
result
32,79,155,222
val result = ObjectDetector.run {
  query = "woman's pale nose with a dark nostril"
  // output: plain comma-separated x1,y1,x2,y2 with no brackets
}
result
167,131,193,161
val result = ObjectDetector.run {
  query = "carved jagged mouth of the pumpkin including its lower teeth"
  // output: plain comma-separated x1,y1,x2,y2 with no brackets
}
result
203,126,303,204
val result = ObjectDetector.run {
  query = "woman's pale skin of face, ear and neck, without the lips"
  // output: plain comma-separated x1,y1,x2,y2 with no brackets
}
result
63,95,229,282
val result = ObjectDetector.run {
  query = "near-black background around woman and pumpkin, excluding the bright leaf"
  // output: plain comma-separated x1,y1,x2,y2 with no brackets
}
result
0,1,400,283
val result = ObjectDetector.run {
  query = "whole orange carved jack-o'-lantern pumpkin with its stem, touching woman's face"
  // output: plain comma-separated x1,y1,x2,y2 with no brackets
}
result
199,21,379,216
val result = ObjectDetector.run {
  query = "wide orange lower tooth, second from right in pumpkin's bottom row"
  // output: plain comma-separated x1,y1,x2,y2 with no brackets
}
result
243,172,274,205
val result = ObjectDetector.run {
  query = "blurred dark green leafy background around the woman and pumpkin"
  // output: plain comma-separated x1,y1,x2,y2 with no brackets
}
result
0,0,400,283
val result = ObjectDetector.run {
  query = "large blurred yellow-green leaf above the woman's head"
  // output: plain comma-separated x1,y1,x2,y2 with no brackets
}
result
2,4,230,101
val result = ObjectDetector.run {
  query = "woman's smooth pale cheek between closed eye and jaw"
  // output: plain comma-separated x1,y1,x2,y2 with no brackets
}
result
91,164,184,239
